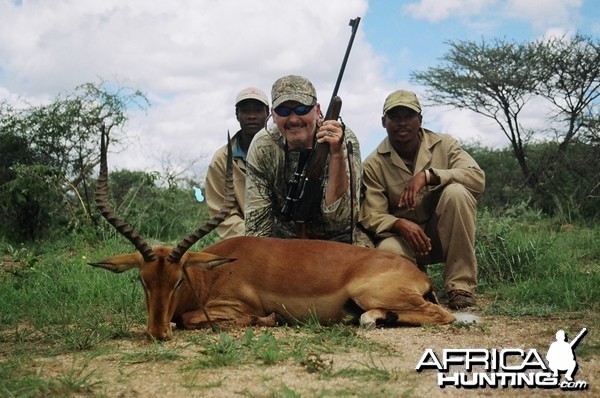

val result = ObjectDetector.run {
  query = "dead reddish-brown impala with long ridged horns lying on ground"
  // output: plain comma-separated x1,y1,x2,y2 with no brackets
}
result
90,133,456,340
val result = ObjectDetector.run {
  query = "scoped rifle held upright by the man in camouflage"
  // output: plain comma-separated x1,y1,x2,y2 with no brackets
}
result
281,17,360,238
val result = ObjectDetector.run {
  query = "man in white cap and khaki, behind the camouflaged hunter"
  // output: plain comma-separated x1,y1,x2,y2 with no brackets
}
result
204,87,269,239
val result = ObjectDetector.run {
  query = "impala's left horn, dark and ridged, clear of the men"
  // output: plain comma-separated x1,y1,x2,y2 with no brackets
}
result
96,125,156,262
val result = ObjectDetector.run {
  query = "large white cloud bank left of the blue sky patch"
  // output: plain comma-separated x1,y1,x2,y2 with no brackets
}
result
0,0,385,176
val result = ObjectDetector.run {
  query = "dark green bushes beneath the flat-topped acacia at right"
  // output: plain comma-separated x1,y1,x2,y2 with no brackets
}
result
465,140,600,221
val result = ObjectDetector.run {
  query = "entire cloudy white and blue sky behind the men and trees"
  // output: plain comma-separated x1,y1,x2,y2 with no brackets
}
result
0,0,600,177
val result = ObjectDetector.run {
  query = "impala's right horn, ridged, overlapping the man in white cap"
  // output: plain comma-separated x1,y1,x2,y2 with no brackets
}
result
168,131,235,263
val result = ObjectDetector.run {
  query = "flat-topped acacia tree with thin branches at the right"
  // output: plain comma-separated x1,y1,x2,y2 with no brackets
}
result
411,35,600,218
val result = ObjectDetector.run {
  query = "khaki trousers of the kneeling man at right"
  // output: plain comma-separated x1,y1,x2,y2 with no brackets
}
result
377,183,477,293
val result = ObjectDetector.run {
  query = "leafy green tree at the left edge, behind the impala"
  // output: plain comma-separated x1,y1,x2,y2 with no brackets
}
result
0,83,148,239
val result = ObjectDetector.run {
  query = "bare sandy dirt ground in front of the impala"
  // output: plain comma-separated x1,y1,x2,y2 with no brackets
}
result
16,316,600,398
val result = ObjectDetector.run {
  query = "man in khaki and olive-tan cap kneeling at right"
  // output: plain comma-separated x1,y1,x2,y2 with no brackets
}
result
360,90,485,309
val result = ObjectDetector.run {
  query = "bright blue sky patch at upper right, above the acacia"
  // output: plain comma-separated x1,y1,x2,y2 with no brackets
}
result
363,0,600,80
